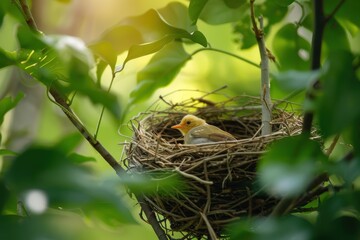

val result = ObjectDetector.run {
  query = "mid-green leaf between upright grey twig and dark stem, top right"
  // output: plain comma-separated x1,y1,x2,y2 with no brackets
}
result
272,24,310,70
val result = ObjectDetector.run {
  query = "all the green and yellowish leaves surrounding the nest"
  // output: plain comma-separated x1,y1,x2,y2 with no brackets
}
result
0,0,360,239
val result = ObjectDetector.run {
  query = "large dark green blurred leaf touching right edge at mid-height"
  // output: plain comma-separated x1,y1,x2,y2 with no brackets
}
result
316,51,360,137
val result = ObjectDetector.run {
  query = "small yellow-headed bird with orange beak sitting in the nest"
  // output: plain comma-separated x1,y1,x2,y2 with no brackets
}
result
171,114,236,144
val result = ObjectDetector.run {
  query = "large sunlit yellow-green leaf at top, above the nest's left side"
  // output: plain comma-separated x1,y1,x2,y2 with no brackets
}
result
90,6,207,71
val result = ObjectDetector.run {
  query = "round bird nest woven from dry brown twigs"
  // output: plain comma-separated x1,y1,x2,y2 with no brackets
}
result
124,94,312,238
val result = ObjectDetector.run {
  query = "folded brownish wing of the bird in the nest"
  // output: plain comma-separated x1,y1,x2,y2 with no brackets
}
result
190,125,236,142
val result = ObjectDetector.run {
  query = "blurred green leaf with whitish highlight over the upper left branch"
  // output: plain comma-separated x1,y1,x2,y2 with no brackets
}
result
18,28,120,118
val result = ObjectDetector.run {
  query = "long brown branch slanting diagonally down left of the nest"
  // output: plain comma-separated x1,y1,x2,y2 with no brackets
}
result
19,0,168,240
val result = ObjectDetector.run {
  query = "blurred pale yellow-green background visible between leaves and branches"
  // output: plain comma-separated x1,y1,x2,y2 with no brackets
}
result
0,0,344,239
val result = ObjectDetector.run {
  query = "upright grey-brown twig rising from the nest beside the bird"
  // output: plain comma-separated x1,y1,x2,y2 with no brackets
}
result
250,0,272,136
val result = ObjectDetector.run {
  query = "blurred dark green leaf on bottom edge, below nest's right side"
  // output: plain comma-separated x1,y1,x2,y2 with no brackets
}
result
229,215,314,240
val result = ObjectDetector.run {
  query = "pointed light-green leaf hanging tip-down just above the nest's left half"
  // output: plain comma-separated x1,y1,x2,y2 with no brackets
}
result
130,42,190,104
